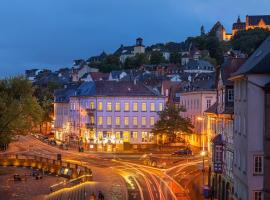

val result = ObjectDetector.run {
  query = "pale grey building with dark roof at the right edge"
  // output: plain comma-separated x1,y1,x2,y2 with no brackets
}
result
232,37,270,200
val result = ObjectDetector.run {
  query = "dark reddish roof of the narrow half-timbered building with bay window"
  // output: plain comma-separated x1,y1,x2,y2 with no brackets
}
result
220,57,247,85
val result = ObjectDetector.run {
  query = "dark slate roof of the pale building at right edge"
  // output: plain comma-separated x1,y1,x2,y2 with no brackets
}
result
232,36,270,76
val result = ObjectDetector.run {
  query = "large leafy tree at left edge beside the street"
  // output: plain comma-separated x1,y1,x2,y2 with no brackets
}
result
0,77,43,146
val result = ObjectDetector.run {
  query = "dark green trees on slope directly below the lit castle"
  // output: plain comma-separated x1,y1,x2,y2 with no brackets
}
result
231,29,270,55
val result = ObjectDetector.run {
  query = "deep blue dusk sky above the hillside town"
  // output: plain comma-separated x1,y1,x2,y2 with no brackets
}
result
0,0,270,77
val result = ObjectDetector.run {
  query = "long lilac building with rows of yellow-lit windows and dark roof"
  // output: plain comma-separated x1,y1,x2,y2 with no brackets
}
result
57,81,165,151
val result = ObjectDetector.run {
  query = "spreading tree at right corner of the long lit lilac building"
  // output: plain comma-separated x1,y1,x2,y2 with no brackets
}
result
152,104,193,142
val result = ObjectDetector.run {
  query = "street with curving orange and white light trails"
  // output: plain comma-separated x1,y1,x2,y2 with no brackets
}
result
0,136,206,200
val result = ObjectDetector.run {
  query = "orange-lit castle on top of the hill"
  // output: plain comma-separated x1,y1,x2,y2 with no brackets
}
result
211,15,270,41
